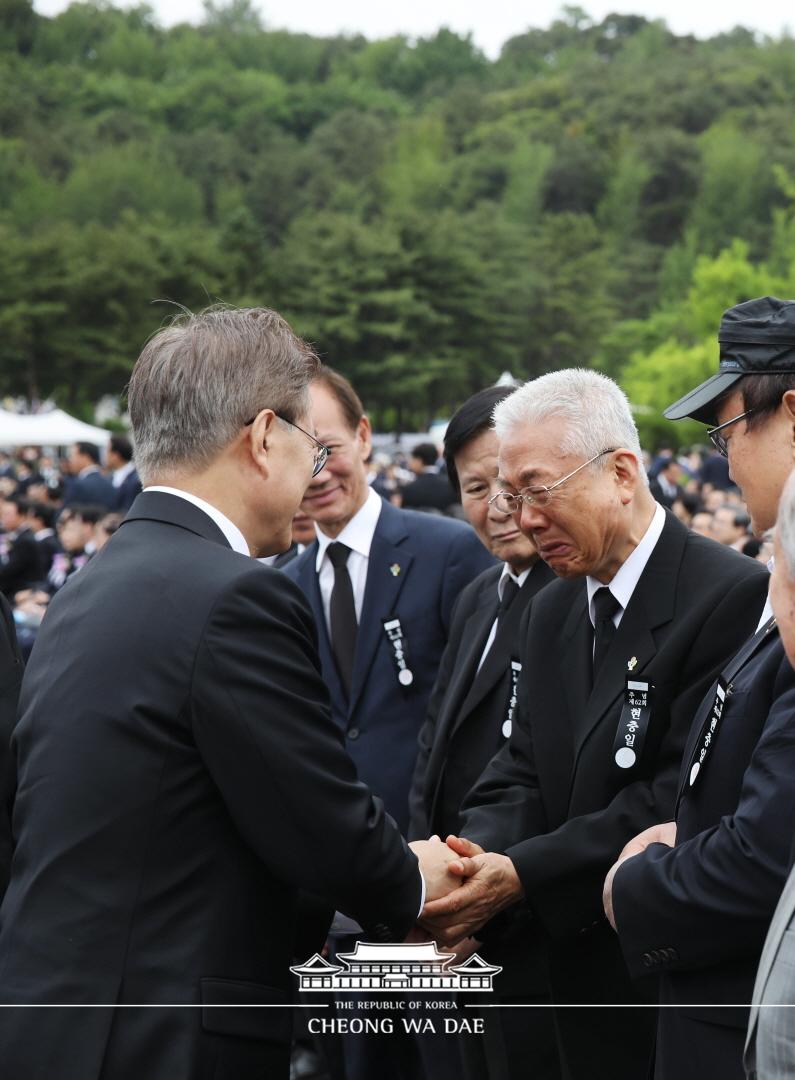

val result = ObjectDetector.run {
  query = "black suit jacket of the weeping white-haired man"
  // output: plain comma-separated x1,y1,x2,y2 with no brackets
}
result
462,512,768,1003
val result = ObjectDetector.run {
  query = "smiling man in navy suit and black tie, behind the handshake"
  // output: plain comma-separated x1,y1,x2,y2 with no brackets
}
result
283,367,494,1080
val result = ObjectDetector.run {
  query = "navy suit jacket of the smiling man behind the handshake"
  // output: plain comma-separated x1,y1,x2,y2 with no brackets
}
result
283,502,494,831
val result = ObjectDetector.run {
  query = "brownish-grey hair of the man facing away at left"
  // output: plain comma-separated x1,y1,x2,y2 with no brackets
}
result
127,306,320,485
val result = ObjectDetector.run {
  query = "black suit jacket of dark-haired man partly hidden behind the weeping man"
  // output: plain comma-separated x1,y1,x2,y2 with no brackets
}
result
408,559,555,839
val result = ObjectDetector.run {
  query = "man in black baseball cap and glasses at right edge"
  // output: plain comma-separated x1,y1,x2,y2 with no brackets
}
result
605,297,795,1080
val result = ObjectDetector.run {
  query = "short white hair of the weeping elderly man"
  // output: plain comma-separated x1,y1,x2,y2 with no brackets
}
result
494,367,646,478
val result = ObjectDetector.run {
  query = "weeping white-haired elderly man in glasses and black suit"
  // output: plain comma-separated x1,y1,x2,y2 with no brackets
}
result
423,369,767,1080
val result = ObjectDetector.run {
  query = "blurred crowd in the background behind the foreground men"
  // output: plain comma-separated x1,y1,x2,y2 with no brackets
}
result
0,425,772,656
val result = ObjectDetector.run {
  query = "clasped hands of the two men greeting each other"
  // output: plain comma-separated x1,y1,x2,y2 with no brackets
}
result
409,836,524,950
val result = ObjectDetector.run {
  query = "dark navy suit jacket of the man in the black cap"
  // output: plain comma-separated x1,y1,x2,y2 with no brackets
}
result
614,626,795,1080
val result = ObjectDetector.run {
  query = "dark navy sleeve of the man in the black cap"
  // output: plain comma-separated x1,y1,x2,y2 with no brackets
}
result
612,660,795,975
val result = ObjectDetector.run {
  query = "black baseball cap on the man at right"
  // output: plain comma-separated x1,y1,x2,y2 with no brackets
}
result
663,296,795,424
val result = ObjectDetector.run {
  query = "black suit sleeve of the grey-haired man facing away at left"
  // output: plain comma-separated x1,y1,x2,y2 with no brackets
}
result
191,566,421,941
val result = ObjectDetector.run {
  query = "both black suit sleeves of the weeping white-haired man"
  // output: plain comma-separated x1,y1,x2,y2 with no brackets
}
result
462,577,760,937
